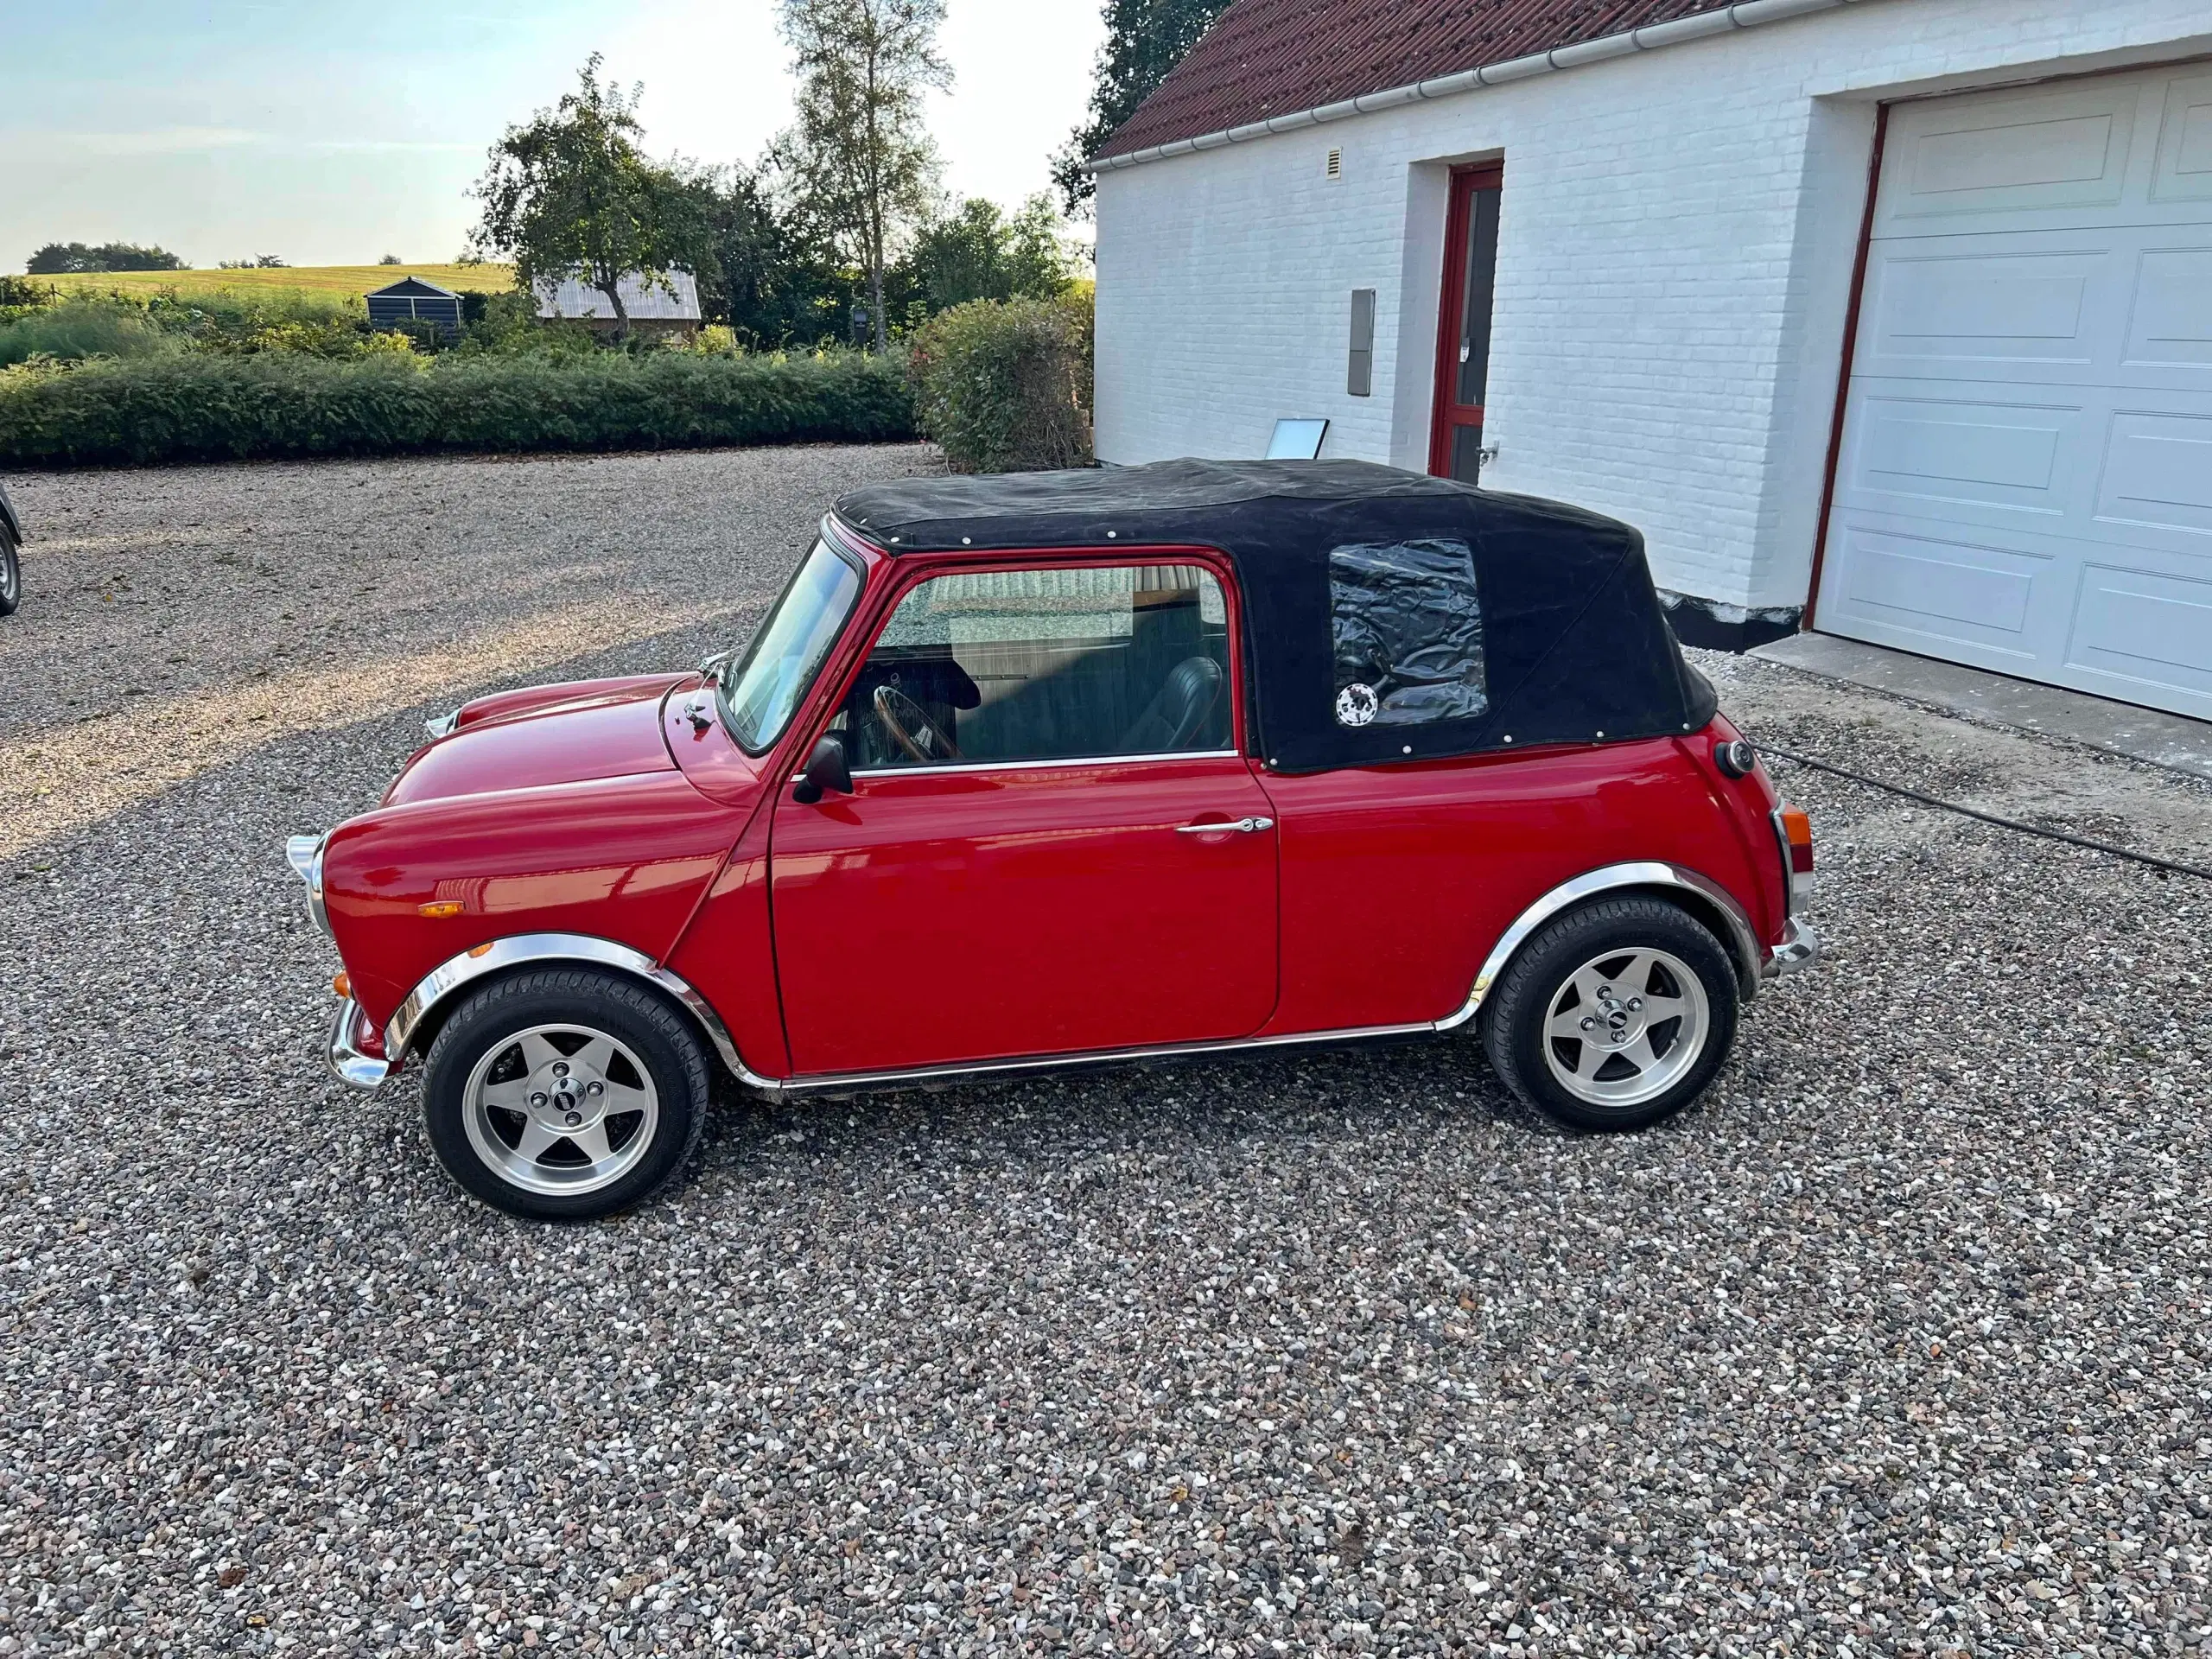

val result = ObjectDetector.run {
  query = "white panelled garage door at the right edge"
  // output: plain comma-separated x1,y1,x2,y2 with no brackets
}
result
1816,64,2212,719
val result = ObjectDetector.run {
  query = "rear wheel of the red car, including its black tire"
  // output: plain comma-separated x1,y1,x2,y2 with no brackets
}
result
1482,893,1738,1130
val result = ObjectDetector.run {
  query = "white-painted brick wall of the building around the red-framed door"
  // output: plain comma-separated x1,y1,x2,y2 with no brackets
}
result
1097,0,2212,606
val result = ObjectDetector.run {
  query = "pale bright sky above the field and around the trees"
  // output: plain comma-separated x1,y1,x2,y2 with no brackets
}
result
0,0,1103,272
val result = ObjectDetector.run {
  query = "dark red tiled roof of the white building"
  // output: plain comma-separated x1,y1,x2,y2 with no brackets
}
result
1099,0,1721,157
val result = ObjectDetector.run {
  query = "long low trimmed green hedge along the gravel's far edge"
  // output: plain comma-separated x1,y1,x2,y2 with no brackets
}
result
0,352,913,465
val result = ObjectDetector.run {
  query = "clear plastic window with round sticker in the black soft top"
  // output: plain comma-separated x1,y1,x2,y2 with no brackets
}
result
1330,542,1491,726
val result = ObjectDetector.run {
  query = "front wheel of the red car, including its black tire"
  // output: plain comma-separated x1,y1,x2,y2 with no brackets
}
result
423,969,712,1221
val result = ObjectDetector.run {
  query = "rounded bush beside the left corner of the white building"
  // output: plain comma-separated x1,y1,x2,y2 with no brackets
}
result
907,296,1090,474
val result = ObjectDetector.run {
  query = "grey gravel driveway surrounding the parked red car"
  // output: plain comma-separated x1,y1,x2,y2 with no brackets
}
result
0,449,2212,1655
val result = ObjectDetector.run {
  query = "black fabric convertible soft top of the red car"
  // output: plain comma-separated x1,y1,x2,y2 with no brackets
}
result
836,460,1717,772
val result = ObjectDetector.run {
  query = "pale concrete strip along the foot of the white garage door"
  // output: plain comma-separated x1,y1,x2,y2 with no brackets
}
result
1750,632,2212,779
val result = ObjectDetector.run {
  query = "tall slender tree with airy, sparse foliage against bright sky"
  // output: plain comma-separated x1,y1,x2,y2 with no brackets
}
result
774,0,951,352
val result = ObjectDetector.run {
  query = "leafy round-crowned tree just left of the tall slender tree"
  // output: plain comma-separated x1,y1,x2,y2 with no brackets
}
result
474,53,706,340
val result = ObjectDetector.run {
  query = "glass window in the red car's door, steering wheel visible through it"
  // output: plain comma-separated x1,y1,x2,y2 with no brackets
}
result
838,564,1232,770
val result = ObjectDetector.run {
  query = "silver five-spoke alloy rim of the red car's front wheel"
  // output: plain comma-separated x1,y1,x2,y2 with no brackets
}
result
460,1024,661,1197
